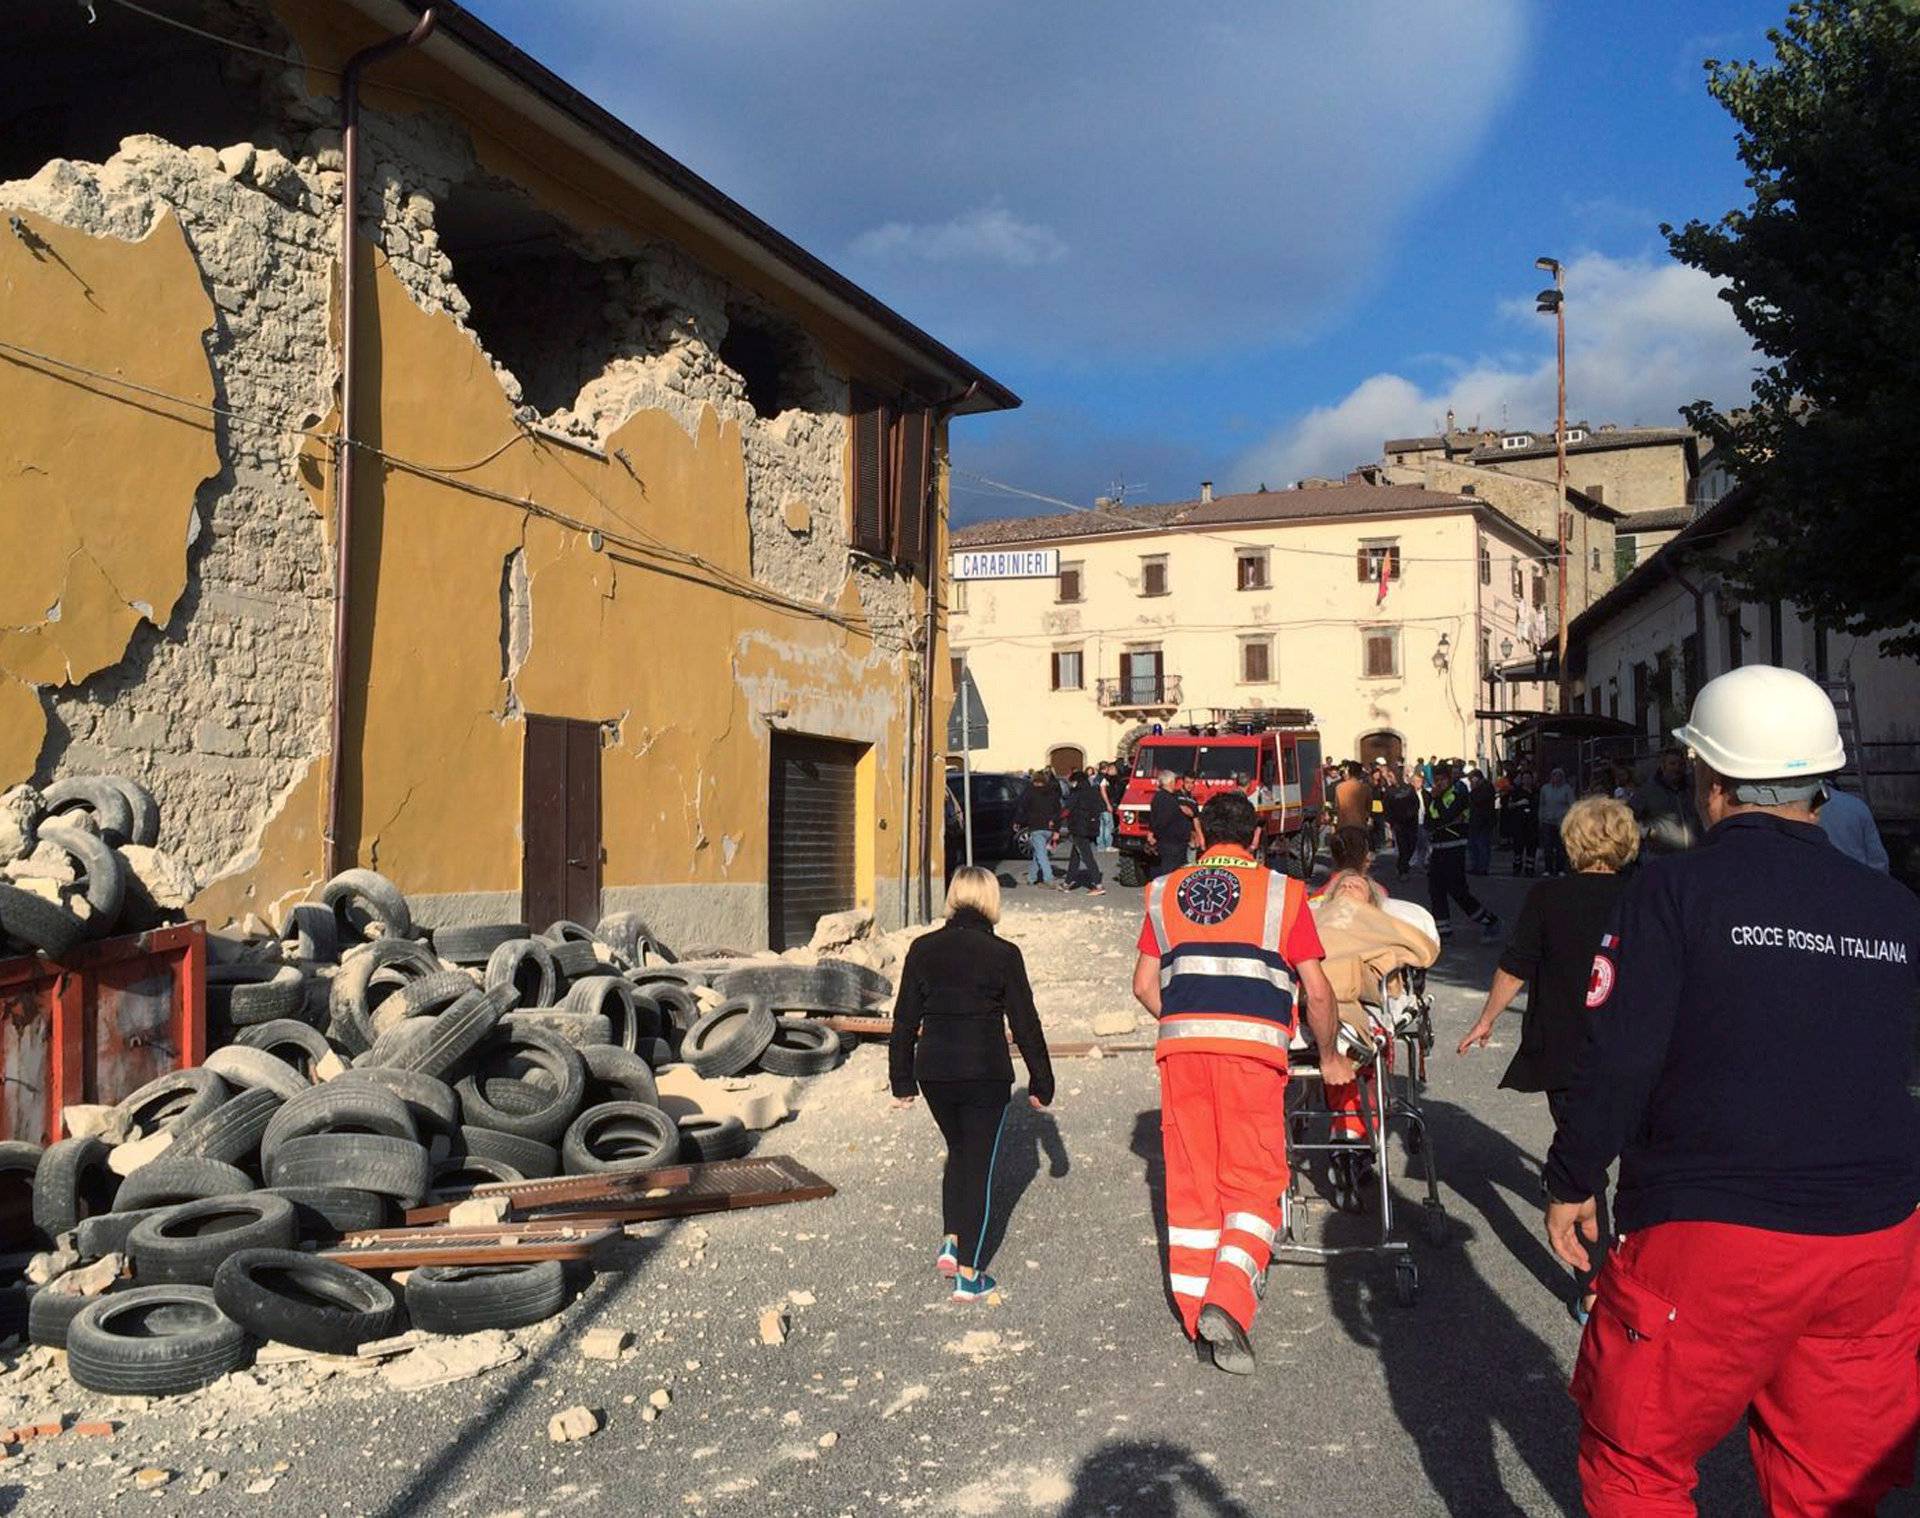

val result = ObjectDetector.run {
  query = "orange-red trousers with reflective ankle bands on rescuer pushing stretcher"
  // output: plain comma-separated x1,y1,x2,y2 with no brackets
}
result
1160,1054,1286,1338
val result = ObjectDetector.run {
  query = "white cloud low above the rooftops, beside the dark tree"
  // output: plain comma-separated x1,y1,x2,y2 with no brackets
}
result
1233,253,1755,486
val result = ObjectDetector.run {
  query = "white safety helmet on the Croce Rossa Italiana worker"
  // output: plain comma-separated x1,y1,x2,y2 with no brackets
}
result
1674,664,1847,781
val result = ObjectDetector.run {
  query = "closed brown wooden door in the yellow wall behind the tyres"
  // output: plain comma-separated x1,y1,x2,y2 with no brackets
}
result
520,716,601,933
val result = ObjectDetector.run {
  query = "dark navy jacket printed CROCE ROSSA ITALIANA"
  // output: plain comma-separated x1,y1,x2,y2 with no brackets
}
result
1546,812,1920,1234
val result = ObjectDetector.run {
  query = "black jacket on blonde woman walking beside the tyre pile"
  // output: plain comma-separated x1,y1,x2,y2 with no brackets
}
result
887,908,1054,1102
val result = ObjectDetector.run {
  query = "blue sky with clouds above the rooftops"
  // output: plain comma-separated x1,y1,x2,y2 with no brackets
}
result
460,0,1786,520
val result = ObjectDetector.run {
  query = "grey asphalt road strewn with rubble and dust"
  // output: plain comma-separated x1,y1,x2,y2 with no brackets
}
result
11,864,1920,1518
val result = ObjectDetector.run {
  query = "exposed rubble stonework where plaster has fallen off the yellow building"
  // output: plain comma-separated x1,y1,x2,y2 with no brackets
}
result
0,65,914,901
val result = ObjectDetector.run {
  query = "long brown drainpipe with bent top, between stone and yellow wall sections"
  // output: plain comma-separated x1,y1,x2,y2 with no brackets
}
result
324,8,438,879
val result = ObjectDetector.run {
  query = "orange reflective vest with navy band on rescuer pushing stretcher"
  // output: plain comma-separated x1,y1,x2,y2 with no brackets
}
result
1146,854,1306,1069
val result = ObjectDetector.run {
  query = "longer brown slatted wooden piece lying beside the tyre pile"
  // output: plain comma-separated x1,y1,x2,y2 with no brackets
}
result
407,1155,835,1226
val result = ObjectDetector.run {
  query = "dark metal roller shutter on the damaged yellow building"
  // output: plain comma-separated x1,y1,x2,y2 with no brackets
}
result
766,733,862,948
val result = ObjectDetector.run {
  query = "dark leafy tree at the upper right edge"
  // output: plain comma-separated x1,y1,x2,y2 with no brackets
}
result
1661,0,1920,654
